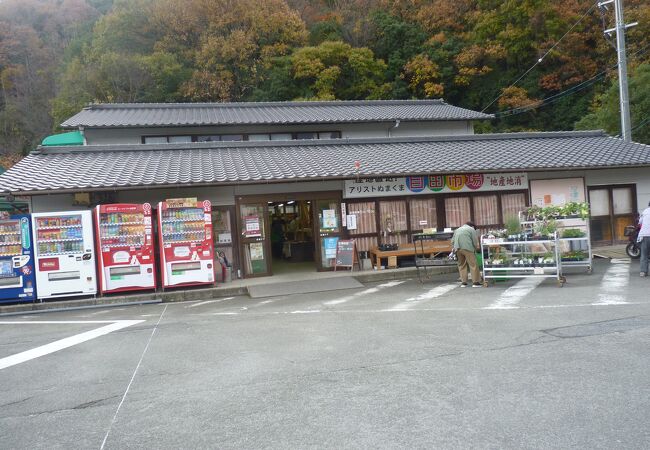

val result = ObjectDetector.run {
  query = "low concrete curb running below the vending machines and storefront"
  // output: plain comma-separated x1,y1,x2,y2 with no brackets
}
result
0,266,457,317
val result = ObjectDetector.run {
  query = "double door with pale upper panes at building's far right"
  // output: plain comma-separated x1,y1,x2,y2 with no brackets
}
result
589,185,636,244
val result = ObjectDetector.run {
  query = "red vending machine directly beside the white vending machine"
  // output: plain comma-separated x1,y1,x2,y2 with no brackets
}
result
95,203,156,293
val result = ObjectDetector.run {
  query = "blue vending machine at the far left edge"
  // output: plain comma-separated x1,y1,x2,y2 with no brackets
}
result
0,214,36,303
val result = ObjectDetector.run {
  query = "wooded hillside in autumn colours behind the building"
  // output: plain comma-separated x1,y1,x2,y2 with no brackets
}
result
0,0,650,161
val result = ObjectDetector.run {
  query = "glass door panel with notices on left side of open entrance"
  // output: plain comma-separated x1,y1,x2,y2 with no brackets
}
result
239,203,271,278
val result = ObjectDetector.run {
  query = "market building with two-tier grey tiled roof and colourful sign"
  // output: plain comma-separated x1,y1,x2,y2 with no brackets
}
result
0,100,650,277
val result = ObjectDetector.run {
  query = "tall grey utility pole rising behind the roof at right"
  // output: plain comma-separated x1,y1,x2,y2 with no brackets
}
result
598,0,638,142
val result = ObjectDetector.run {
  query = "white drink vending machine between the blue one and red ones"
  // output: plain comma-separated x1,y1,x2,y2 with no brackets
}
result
32,211,97,299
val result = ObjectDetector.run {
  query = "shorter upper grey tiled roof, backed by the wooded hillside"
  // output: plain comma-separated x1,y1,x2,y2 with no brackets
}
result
61,100,494,128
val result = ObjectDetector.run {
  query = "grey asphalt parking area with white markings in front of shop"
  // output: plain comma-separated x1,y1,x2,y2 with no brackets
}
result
0,261,650,449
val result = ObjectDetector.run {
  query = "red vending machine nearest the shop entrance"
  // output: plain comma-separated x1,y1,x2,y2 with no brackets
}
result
158,198,215,287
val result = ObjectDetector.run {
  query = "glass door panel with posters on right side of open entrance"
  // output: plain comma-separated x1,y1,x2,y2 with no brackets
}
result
312,198,343,271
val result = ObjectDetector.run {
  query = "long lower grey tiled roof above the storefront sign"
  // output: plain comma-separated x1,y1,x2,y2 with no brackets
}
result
0,132,650,194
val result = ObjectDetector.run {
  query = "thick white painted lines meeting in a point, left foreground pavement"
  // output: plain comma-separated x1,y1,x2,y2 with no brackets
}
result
0,320,144,370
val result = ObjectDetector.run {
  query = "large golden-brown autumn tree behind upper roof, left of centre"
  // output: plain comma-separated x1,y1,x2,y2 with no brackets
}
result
154,0,307,101
